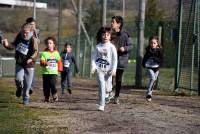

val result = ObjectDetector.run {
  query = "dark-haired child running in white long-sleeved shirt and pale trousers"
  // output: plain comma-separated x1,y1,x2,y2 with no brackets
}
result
91,27,117,111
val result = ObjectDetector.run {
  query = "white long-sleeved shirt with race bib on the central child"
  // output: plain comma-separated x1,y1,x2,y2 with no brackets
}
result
92,42,117,72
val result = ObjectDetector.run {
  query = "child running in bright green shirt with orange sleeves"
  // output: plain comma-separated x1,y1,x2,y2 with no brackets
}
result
40,37,63,102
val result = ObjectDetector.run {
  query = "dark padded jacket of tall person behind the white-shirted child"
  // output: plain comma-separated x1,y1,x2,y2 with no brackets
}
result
114,31,133,69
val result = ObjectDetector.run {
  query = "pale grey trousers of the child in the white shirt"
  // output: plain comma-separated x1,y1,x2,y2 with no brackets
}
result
97,71,112,106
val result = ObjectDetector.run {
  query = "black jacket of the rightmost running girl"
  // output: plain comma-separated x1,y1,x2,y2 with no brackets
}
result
142,47,163,70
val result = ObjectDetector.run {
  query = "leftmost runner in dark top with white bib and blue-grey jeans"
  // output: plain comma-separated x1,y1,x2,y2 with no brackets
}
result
2,23,38,105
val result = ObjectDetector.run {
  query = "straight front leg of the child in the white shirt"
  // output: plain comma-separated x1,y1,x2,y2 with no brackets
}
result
97,71,106,106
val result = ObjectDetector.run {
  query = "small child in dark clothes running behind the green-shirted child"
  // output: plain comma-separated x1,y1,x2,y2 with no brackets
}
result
61,42,79,94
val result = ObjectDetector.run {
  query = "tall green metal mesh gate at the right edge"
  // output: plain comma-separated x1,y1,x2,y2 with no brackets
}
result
175,0,200,95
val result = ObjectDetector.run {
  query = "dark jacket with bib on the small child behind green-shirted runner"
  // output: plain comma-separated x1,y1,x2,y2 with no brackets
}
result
61,51,79,73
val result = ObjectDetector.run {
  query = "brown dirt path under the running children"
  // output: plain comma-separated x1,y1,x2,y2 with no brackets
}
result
4,80,200,134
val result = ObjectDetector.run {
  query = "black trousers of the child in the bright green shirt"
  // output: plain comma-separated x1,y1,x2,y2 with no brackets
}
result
43,74,57,97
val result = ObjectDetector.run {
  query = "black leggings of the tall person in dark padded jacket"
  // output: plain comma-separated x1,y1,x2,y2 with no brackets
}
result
115,69,124,97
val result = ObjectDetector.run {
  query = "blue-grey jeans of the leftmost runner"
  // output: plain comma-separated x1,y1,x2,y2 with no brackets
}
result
15,64,34,98
